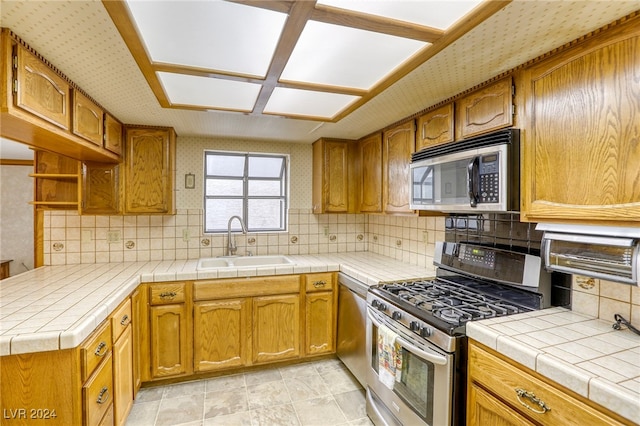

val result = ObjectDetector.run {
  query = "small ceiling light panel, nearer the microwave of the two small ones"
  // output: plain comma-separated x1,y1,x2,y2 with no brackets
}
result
264,87,360,119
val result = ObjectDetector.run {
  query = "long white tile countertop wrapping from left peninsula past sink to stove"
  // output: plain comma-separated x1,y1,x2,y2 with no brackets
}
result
0,252,435,356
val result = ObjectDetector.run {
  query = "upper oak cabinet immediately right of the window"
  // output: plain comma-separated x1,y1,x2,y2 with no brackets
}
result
313,139,350,213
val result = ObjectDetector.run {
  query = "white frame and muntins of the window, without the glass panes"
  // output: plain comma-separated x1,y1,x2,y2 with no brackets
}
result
202,150,290,234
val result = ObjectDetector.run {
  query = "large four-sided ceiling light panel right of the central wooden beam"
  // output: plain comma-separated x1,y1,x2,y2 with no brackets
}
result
281,21,427,90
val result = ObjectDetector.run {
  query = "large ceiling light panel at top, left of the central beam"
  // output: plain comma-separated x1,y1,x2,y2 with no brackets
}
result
127,0,287,77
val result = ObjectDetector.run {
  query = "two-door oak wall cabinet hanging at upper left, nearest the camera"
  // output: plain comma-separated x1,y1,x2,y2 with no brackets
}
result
0,28,120,163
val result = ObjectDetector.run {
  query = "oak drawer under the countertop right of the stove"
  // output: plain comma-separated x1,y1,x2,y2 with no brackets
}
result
469,345,621,426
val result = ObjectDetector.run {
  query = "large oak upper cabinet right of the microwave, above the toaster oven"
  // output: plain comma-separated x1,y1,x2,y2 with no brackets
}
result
521,16,640,224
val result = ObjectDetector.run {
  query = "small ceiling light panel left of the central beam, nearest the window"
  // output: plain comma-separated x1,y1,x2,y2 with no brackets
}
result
156,72,262,112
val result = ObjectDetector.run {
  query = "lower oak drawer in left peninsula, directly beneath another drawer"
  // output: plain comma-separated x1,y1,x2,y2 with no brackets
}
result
82,353,113,425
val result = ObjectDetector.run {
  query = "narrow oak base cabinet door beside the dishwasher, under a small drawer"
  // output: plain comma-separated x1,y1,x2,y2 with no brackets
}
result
305,291,335,355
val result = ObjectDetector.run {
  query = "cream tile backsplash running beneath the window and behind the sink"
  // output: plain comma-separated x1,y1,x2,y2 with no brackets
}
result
44,209,444,266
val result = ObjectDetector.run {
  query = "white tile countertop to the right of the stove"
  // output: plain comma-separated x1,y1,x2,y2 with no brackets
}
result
466,308,640,424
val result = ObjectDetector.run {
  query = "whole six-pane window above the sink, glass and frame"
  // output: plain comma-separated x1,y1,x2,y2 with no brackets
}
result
204,151,288,233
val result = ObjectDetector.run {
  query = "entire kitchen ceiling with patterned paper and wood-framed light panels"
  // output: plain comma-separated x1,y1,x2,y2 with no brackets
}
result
0,0,640,143
